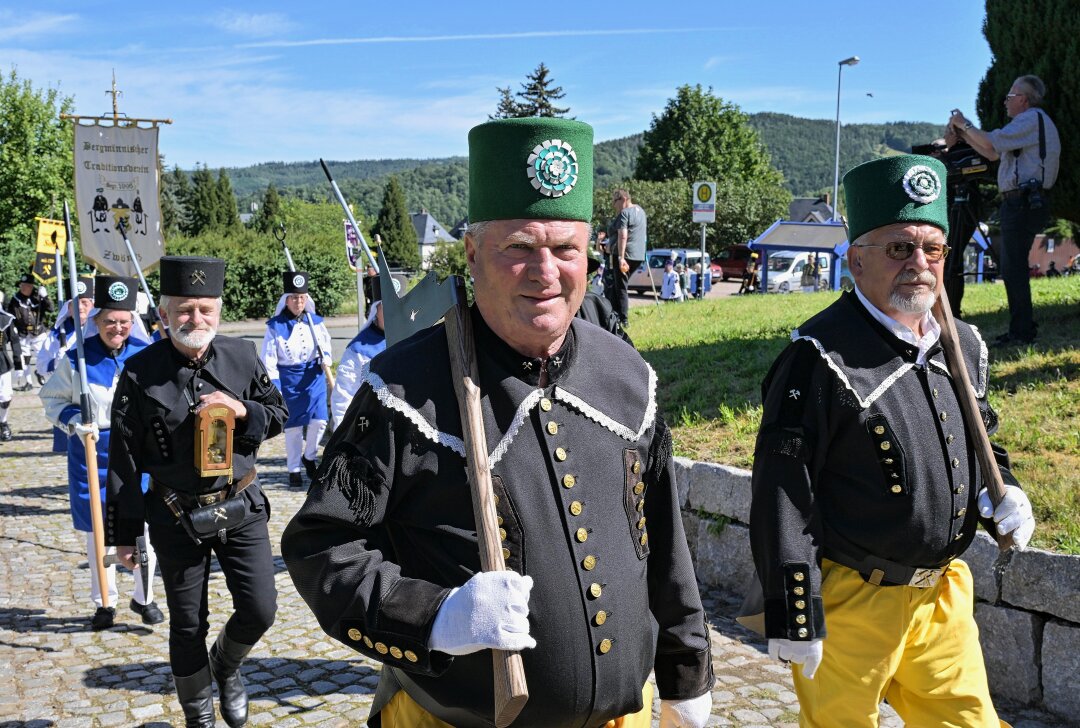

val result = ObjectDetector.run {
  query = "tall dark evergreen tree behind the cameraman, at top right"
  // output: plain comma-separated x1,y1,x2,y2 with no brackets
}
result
976,0,1080,221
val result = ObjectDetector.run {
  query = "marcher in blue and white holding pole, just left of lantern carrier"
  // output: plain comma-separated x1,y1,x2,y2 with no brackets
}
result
39,275,165,630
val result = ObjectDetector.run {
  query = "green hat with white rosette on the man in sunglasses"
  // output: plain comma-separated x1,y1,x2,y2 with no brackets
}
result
843,154,948,242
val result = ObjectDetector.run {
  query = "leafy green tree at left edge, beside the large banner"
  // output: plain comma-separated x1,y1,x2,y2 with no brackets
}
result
0,69,73,291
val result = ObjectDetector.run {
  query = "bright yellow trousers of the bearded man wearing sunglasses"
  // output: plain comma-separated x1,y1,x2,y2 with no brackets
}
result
792,560,1008,728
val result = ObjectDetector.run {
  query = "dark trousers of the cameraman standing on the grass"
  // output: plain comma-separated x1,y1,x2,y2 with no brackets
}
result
999,194,1050,340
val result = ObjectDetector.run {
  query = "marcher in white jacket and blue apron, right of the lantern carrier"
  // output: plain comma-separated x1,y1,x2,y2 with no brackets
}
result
260,270,333,488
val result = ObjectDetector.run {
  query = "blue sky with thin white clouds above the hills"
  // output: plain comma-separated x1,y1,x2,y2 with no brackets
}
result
0,0,990,167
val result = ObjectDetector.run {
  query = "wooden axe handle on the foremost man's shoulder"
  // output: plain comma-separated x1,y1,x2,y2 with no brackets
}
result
446,295,529,728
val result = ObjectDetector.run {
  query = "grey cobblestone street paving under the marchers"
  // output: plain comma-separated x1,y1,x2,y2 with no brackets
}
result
0,384,1061,728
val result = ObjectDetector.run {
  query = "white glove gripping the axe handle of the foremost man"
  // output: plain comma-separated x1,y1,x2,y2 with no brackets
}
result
428,571,537,655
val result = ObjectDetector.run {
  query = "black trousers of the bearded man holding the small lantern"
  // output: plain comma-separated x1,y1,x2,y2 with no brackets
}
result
146,484,278,677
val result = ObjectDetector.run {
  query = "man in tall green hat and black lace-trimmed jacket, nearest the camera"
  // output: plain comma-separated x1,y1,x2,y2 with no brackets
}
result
282,118,713,728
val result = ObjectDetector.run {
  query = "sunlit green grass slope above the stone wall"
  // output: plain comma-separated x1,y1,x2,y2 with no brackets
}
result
630,277,1080,554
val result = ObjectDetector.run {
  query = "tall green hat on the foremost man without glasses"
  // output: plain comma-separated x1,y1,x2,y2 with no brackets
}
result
469,117,593,223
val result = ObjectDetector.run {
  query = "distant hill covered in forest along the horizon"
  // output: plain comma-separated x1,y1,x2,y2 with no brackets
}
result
227,113,942,227
